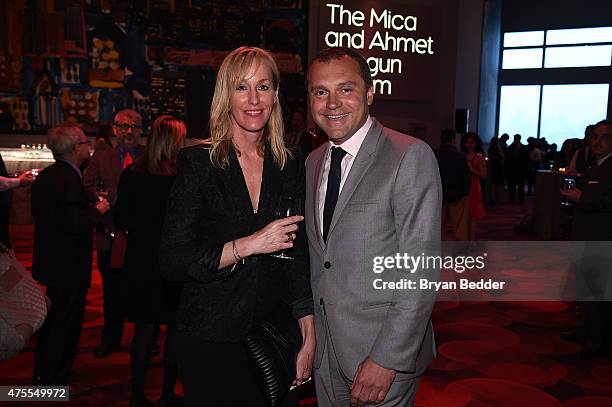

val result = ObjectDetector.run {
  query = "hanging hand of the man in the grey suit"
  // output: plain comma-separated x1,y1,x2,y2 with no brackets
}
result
351,356,395,407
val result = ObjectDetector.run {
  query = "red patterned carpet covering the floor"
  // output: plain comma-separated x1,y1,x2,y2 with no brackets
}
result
0,199,612,407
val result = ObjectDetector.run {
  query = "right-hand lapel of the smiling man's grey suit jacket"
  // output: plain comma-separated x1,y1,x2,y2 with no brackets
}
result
327,119,382,244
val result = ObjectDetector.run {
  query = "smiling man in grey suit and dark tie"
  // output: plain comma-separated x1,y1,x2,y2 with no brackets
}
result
306,48,442,407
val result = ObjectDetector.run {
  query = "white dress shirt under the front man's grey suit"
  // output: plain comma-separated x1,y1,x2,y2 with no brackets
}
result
319,116,372,233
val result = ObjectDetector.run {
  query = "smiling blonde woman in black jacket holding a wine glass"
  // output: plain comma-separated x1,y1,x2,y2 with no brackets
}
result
161,47,315,406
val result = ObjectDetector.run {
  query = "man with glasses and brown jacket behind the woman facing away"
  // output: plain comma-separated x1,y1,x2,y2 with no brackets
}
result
83,109,144,358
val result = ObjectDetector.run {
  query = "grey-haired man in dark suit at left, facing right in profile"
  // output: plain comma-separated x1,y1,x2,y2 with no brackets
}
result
32,125,110,386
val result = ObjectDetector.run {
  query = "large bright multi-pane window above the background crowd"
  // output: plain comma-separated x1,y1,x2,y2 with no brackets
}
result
497,27,612,146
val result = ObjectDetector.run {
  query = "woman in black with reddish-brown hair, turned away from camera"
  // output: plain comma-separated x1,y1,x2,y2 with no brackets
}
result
115,116,187,406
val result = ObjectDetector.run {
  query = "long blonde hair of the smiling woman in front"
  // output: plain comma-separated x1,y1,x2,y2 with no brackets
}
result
208,47,290,169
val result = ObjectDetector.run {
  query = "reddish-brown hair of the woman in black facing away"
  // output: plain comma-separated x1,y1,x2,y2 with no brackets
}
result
135,115,187,175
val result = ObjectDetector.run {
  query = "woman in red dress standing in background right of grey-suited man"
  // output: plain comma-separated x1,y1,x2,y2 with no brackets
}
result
461,132,487,240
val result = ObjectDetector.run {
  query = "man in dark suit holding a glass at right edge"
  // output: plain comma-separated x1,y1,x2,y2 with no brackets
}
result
561,120,612,357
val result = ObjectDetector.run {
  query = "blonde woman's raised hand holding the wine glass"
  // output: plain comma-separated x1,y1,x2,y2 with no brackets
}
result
246,216,304,255
